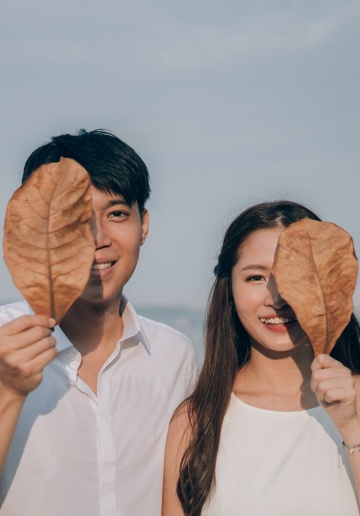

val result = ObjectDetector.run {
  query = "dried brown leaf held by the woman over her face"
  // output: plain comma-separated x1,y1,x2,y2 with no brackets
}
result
272,219,358,356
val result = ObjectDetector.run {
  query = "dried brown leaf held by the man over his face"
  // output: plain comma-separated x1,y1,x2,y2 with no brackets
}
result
3,158,95,323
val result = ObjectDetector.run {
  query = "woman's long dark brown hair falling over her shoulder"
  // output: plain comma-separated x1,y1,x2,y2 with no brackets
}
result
177,201,360,516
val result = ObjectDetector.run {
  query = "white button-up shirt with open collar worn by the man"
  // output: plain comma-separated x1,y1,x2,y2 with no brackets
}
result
0,299,196,516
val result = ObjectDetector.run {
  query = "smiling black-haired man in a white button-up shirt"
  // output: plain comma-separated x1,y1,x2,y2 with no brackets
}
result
0,130,196,516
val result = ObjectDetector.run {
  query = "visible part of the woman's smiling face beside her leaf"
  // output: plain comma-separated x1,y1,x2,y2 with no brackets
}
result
231,228,309,352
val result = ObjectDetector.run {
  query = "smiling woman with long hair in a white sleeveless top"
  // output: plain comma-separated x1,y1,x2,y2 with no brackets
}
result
162,201,360,516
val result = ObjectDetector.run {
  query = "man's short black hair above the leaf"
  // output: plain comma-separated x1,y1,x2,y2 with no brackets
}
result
22,129,150,212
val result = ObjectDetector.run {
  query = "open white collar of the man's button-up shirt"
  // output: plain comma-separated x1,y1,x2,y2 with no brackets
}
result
54,295,151,355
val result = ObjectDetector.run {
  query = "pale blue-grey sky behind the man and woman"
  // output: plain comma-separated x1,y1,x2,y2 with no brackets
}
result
0,0,360,306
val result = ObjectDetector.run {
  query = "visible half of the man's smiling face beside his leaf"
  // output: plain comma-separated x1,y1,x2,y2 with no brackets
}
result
80,186,149,303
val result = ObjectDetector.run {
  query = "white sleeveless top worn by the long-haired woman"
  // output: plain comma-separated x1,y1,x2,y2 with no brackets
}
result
202,394,359,516
